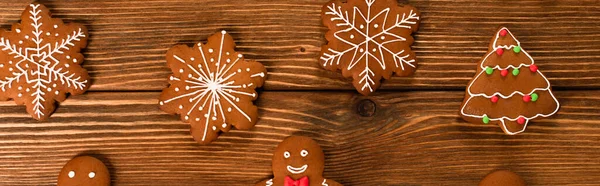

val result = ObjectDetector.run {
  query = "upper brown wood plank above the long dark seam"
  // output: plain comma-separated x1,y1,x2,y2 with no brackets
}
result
0,0,600,91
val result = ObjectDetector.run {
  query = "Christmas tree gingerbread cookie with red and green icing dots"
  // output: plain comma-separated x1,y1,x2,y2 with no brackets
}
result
460,28,560,135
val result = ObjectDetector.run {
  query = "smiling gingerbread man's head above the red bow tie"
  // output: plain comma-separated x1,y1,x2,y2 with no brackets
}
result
273,136,325,180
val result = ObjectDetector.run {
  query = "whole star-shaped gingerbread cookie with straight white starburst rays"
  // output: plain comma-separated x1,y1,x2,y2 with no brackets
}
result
159,31,267,144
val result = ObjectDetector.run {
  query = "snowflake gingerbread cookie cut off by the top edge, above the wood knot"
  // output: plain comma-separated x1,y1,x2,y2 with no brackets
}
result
321,0,421,95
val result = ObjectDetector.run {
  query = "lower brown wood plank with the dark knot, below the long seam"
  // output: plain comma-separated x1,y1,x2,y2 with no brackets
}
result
0,91,600,186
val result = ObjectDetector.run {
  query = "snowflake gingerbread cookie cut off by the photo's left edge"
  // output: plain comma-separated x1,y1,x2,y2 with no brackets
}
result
0,3,90,120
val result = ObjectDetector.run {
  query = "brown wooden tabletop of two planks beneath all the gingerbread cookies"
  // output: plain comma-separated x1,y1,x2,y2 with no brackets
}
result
0,0,600,186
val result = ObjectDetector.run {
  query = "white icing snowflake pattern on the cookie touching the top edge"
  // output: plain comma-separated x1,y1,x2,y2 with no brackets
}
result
321,0,420,92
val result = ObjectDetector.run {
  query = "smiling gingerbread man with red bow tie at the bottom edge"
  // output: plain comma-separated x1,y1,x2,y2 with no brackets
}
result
256,136,342,186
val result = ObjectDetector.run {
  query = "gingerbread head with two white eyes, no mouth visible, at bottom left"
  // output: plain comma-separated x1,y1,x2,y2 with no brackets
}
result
57,156,110,186
